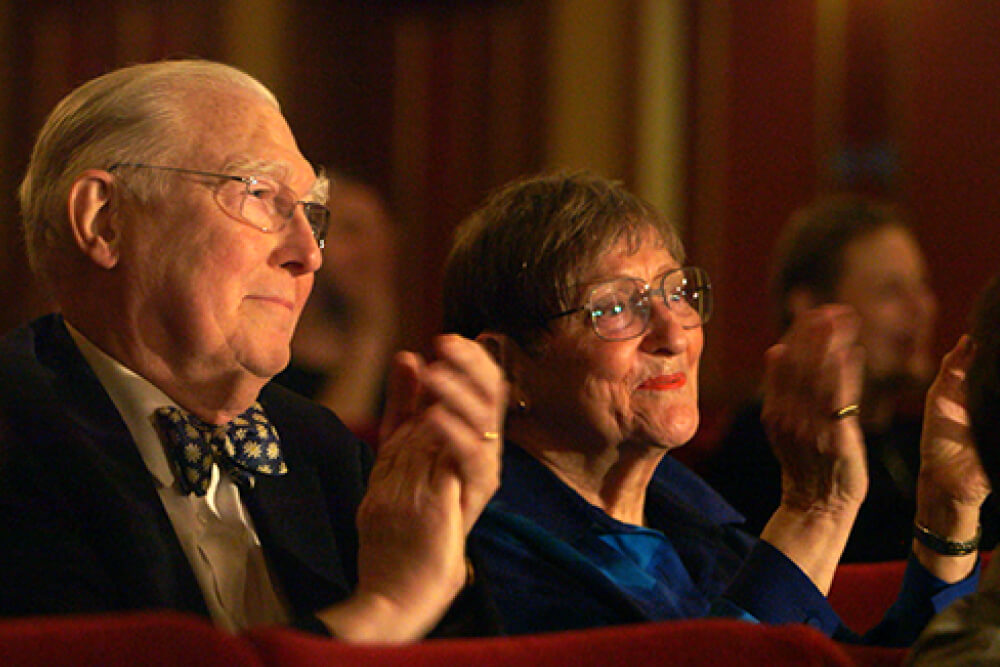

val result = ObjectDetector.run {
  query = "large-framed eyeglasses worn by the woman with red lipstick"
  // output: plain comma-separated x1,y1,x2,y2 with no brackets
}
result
551,266,712,341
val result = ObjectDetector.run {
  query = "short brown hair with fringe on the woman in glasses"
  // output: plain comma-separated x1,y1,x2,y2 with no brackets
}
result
444,171,684,348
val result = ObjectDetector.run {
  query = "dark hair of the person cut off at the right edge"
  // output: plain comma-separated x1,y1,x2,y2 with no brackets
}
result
966,275,1000,489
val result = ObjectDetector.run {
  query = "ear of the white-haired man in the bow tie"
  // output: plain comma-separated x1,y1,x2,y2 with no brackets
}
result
67,169,121,269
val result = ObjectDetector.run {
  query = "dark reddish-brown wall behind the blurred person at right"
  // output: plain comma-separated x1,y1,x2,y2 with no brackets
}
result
688,0,1000,418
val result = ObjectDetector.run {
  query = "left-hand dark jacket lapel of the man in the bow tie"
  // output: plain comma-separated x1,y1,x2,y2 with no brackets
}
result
29,317,208,615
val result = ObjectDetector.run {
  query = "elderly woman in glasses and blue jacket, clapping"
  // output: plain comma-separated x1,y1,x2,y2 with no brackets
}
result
445,173,987,645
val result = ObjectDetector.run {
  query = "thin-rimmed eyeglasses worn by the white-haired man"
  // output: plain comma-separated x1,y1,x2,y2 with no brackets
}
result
108,162,330,248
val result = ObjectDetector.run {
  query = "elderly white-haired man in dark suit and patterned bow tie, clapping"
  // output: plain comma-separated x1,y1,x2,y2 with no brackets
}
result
0,61,504,641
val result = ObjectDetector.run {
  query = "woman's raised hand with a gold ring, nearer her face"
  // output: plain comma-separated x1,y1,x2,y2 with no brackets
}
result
761,305,868,593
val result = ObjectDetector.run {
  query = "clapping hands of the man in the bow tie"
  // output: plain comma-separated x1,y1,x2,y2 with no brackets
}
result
320,335,506,641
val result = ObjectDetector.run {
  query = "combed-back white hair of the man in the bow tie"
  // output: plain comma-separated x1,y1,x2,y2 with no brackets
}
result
18,60,279,292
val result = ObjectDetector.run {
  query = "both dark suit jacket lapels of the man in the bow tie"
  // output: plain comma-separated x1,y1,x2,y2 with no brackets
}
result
28,316,364,615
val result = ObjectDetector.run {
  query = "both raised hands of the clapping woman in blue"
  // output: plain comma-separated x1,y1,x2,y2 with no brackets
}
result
761,305,990,592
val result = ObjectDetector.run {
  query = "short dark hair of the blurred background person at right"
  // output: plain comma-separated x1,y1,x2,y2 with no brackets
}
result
771,194,909,329
